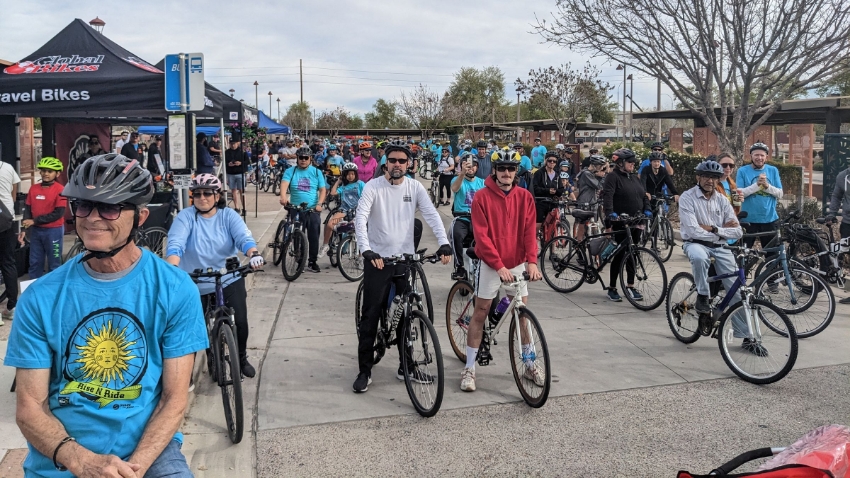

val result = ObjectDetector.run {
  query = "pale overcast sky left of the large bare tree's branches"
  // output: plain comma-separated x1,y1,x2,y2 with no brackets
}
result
0,0,672,117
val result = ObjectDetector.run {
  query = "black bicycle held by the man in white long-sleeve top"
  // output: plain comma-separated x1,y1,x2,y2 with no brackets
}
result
354,253,444,417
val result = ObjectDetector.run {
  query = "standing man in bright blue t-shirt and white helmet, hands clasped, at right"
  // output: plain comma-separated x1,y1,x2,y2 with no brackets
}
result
735,143,782,252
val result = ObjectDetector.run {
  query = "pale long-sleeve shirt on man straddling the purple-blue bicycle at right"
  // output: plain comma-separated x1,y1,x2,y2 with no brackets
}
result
679,186,744,244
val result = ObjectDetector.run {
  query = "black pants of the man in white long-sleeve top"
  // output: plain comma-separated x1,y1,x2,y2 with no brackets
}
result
357,261,408,374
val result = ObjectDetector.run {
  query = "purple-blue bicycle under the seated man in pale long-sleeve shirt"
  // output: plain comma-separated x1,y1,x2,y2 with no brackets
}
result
666,245,797,385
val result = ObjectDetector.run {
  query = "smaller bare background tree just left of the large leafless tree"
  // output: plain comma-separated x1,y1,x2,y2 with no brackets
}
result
516,63,611,137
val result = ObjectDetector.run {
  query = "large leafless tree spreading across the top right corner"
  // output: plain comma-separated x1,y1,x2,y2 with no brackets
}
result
536,0,850,158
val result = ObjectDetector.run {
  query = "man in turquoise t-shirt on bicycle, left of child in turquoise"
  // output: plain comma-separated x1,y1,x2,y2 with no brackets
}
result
280,146,328,272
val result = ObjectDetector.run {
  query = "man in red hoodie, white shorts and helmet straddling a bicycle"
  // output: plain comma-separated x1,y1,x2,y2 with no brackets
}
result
460,151,544,392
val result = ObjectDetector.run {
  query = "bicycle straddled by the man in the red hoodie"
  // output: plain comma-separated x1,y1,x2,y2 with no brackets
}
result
446,248,552,408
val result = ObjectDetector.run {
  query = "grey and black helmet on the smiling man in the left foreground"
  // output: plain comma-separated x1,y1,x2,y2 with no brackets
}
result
62,153,154,206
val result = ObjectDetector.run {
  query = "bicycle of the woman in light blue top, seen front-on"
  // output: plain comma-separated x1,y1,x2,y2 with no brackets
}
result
189,257,257,443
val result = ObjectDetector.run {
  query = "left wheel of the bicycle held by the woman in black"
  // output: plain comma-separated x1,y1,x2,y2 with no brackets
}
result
540,236,587,293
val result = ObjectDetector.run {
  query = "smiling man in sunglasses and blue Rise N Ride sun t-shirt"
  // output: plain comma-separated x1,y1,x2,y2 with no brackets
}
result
5,155,209,476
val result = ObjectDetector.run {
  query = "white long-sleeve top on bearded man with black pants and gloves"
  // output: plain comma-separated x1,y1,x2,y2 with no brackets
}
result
354,177,449,257
